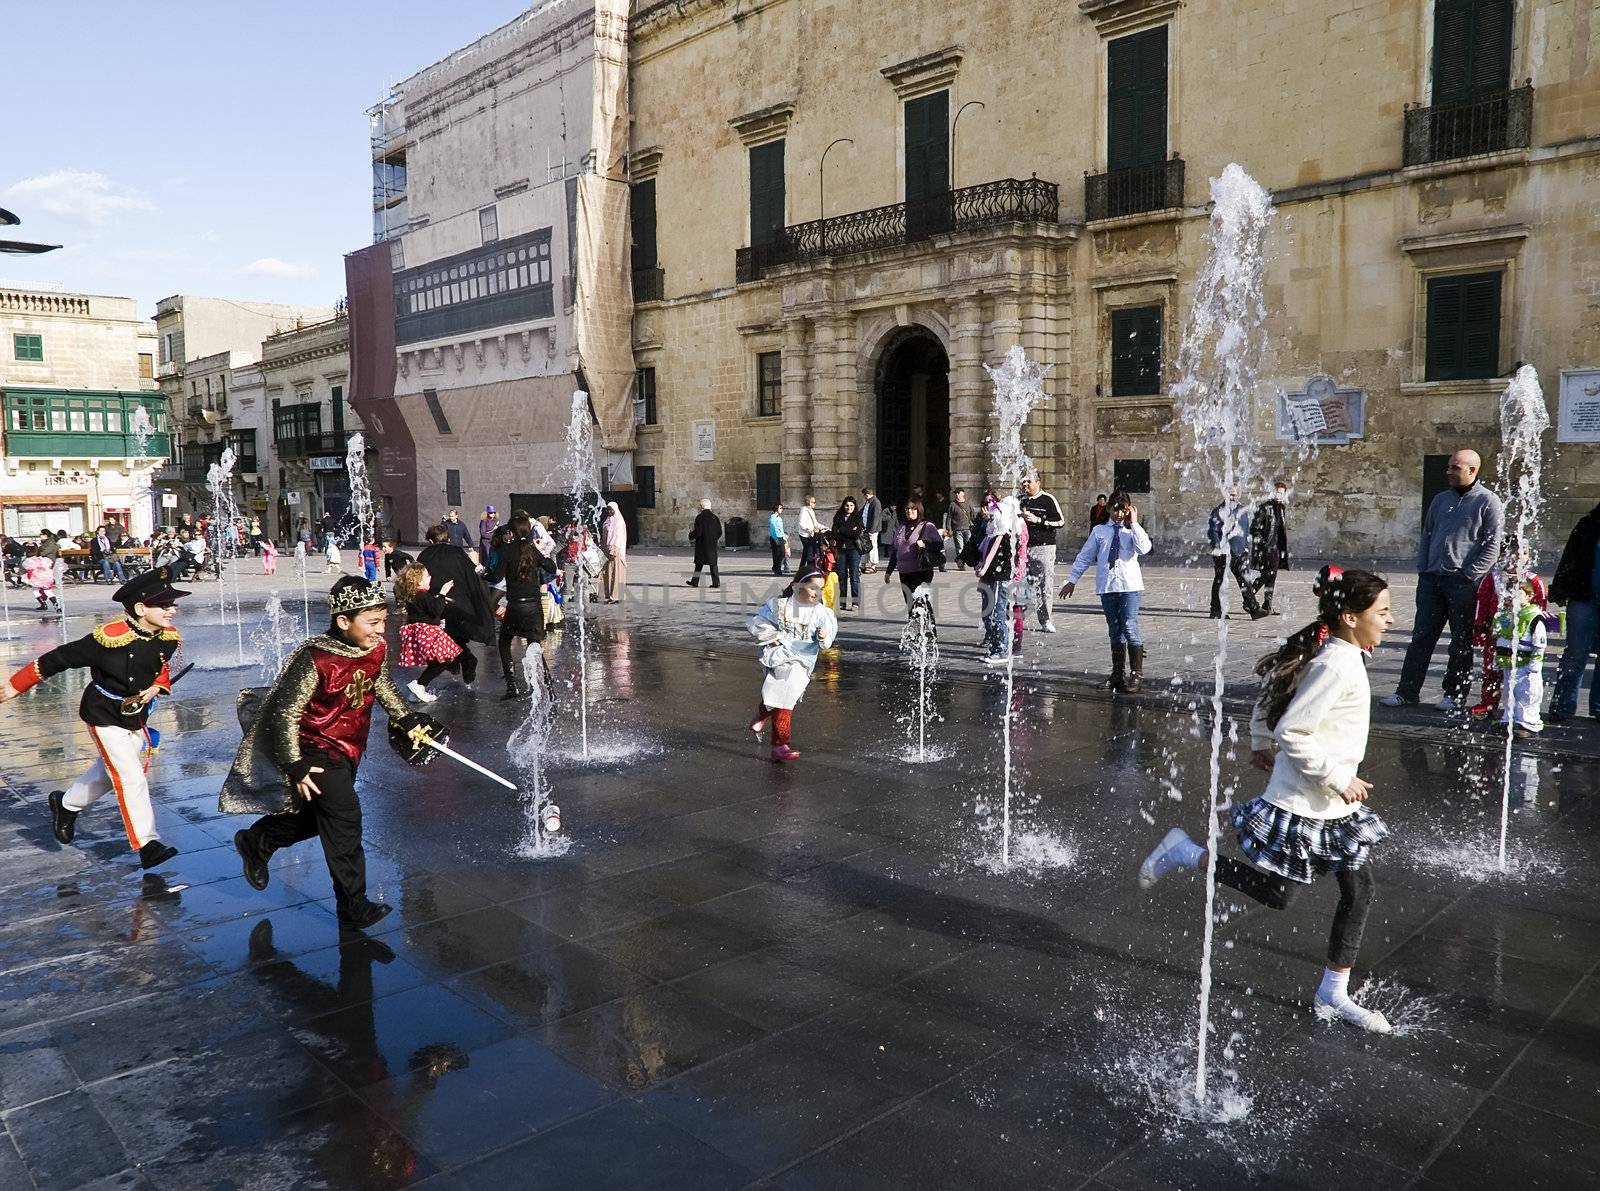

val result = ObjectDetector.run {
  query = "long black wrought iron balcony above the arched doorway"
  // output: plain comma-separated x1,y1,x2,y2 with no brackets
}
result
734,178,1061,283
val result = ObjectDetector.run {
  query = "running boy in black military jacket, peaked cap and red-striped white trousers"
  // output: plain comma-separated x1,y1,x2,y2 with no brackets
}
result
0,567,189,869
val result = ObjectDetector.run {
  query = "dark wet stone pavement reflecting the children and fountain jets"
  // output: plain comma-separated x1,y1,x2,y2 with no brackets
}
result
0,604,1600,1191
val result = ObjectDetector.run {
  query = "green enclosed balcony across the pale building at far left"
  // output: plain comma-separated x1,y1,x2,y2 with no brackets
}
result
5,389,173,459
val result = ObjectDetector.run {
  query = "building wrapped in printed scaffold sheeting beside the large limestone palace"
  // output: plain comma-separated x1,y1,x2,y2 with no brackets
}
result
346,0,634,541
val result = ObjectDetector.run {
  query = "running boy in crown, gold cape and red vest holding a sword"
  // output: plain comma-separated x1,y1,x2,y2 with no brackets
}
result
218,576,446,930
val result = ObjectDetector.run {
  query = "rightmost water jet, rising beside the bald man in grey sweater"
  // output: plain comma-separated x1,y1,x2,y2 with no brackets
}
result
1499,363,1550,872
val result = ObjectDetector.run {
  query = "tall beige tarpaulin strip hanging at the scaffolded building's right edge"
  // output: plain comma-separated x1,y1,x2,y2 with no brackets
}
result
573,0,634,451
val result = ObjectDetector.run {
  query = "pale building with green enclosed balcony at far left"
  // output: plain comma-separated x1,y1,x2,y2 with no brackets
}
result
0,288,171,538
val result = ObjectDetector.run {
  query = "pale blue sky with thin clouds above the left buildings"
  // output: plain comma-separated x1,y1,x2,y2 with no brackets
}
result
0,0,528,315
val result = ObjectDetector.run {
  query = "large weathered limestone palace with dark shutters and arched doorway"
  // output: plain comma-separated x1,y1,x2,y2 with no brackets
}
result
629,0,1600,557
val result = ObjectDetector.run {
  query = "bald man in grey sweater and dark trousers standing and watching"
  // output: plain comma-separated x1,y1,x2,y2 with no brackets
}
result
1382,450,1506,712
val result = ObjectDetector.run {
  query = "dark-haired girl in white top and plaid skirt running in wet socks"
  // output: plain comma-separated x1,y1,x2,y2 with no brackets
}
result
1139,567,1394,1034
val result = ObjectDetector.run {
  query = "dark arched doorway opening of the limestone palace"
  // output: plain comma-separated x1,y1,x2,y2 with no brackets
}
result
875,327,950,506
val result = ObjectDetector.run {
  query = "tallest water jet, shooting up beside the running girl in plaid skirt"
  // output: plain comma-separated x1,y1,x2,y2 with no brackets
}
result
1173,163,1274,1108
